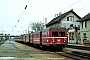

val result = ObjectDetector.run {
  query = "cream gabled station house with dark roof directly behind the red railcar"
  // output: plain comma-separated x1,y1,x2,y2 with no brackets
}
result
46,9,81,43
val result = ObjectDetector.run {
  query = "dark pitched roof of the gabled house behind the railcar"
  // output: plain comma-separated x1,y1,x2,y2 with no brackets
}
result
46,9,81,26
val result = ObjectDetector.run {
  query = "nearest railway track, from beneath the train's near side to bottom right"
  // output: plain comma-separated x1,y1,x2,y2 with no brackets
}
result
18,42,90,60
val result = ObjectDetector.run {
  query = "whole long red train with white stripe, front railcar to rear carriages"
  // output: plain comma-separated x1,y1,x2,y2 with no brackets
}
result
15,27,68,50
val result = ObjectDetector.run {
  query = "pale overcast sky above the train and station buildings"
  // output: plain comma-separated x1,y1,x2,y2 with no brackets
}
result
0,0,90,35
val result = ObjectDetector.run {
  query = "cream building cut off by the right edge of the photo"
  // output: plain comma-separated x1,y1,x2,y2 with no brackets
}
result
77,13,90,43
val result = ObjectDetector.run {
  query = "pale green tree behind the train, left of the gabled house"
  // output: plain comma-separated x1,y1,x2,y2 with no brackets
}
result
30,22,45,31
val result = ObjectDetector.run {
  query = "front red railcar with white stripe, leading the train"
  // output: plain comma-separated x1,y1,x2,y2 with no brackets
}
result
42,27,68,49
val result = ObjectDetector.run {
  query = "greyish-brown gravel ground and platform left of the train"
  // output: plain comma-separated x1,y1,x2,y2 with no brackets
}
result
0,41,72,60
